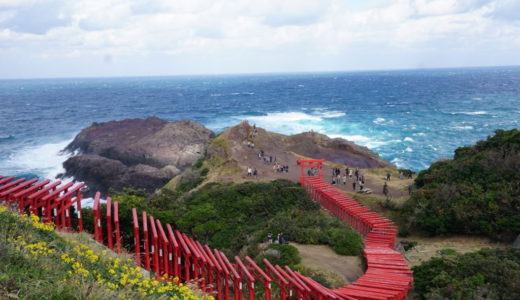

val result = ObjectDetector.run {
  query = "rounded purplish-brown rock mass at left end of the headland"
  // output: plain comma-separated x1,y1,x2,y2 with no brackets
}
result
63,117,215,192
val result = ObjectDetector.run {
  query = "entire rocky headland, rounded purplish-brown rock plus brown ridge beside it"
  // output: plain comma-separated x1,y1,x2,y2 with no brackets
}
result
63,117,395,193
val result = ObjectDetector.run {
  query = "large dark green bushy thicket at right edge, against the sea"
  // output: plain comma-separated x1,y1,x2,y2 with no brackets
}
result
404,129,520,241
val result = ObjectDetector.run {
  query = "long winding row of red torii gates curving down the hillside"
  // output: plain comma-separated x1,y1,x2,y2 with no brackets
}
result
0,171,412,300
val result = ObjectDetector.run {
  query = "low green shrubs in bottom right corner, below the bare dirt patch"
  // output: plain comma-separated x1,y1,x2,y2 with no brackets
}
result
413,248,520,299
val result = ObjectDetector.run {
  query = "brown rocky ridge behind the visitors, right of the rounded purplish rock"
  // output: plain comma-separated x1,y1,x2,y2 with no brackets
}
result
208,122,395,181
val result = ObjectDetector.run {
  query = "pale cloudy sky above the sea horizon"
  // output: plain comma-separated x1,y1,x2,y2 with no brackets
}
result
0,0,520,78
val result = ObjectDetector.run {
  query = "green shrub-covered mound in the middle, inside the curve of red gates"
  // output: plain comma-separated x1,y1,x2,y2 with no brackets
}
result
105,180,362,255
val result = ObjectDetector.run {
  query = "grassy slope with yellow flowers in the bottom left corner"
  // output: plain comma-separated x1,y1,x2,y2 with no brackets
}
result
0,206,204,300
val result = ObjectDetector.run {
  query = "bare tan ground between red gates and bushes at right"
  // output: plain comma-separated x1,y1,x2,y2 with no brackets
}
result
398,236,508,267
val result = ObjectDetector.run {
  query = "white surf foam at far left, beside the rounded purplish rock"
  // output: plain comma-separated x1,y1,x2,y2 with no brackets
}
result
5,140,72,179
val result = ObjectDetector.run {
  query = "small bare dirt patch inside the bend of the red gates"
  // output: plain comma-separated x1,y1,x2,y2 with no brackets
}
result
291,243,363,284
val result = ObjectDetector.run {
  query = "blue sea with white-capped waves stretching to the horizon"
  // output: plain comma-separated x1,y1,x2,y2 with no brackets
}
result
0,67,520,177
